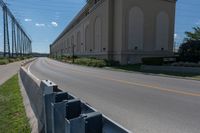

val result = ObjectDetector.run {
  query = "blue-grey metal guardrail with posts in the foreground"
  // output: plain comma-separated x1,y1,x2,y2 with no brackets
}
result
40,80,129,133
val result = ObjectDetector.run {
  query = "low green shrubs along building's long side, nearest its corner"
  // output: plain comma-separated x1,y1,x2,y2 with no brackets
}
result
74,58,106,67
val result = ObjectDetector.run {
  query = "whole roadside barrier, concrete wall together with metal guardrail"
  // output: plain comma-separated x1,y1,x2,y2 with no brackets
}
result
20,68,130,133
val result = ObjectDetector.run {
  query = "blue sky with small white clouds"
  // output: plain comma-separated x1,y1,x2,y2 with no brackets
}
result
0,0,200,53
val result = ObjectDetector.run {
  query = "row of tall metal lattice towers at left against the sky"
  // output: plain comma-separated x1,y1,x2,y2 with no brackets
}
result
0,0,32,57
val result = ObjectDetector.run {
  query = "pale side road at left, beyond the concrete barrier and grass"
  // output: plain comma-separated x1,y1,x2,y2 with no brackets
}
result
0,62,21,85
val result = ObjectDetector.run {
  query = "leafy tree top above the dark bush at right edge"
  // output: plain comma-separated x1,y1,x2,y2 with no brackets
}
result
185,26,200,42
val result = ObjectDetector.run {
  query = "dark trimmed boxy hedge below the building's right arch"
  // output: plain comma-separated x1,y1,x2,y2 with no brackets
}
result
142,57,164,65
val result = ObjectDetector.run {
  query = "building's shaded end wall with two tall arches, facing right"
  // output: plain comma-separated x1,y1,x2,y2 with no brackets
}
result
114,0,175,64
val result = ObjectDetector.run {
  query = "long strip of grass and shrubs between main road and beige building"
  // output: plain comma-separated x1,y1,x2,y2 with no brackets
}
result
51,56,200,80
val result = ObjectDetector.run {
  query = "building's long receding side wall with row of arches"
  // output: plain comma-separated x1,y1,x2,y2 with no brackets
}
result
52,0,109,58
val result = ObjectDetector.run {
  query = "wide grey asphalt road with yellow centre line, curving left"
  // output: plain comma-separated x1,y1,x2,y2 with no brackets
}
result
30,58,200,133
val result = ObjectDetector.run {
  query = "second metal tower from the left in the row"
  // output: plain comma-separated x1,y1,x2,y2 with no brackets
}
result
12,18,17,56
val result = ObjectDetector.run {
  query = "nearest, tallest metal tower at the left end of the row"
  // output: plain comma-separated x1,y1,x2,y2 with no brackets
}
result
3,6,10,57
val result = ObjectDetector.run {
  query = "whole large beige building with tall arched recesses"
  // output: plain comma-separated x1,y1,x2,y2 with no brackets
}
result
50,0,176,64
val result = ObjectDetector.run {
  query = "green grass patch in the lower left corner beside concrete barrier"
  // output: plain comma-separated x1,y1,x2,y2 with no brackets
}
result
0,75,31,133
